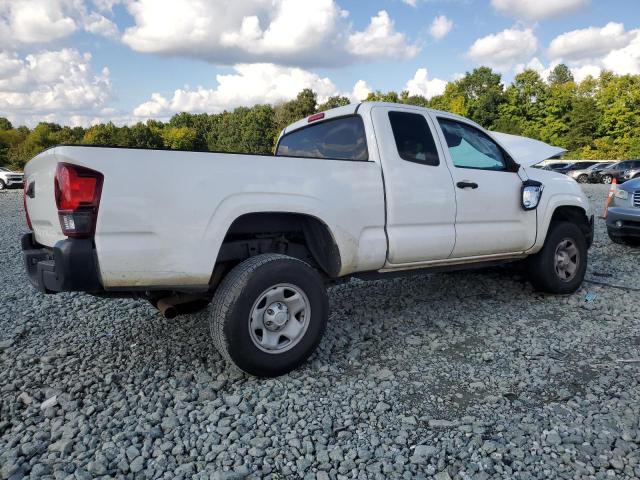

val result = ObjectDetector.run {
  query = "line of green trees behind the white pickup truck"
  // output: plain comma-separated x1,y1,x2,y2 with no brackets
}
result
0,64,640,169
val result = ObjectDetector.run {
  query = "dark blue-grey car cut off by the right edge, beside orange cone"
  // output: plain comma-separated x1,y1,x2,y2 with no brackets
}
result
607,177,640,245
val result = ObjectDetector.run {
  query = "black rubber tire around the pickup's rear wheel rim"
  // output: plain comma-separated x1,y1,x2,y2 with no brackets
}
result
209,254,329,377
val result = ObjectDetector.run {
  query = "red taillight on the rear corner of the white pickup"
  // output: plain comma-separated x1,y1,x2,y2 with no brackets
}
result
54,163,104,238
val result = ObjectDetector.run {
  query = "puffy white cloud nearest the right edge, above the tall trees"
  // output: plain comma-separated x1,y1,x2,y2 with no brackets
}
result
549,22,633,60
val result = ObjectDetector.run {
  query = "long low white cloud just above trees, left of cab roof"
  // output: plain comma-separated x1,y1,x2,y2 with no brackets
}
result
133,63,344,118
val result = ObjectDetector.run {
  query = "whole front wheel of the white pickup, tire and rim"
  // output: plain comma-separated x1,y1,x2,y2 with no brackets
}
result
527,222,587,294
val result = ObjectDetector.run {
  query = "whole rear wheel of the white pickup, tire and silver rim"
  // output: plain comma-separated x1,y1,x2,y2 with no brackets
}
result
210,254,328,377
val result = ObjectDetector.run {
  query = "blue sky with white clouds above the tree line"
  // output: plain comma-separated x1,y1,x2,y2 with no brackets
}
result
0,0,640,126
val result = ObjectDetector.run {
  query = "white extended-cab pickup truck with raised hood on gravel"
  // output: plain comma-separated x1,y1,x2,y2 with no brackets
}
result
22,103,593,376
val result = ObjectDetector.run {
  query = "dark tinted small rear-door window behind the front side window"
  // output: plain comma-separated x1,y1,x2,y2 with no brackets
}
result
389,112,440,165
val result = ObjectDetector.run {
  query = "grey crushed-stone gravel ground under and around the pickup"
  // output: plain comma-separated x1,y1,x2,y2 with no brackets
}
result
0,185,640,480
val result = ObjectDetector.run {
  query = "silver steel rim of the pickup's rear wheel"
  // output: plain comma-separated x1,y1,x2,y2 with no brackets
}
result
249,283,311,354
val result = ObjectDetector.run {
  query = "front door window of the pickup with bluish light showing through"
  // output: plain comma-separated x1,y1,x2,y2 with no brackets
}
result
438,118,506,170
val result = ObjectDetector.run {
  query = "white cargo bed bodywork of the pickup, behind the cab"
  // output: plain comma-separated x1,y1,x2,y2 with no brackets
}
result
25,146,386,289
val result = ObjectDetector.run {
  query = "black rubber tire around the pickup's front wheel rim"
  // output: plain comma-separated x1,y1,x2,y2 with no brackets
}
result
527,222,587,294
